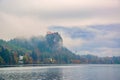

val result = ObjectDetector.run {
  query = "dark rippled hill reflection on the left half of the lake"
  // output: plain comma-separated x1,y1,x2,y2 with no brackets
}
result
0,68,62,80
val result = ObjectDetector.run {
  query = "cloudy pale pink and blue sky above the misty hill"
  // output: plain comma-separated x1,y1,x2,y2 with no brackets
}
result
0,0,120,56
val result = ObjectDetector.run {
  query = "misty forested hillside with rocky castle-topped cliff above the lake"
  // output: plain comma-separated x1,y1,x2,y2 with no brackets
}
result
0,32,120,65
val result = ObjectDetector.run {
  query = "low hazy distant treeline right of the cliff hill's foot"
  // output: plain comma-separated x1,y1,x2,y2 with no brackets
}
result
80,55,120,64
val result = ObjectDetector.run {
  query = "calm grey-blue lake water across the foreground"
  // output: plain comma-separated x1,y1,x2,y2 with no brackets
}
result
0,64,120,80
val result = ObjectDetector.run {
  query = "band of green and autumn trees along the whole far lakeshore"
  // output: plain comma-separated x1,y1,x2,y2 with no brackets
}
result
0,46,120,65
